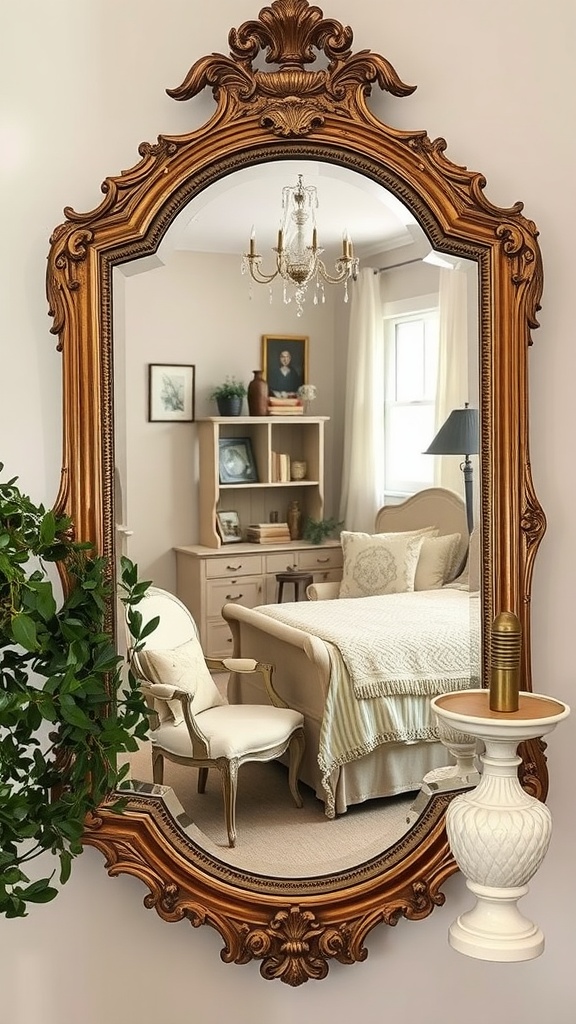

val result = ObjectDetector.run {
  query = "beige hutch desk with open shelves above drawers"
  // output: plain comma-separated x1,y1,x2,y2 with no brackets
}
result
175,416,342,657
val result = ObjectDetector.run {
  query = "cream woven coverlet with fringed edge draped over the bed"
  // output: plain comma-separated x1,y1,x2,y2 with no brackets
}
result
253,590,479,817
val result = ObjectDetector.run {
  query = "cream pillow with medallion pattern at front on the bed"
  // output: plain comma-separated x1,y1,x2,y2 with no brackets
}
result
338,530,428,597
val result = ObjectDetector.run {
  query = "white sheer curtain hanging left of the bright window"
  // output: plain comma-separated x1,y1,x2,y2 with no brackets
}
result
340,267,384,532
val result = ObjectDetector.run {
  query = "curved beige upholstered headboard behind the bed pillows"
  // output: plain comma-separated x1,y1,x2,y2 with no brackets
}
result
375,487,468,566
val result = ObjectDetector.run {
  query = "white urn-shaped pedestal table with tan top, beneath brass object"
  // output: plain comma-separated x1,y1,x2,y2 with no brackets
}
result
431,690,570,962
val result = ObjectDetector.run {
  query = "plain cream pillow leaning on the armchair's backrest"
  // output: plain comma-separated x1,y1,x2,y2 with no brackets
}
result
138,640,225,725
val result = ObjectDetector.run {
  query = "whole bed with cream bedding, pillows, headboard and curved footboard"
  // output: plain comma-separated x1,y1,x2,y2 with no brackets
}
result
222,487,480,817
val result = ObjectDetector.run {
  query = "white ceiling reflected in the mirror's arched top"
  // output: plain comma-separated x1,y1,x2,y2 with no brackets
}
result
165,160,429,270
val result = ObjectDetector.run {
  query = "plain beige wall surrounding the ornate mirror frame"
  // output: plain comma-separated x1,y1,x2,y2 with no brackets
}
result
0,0,576,1024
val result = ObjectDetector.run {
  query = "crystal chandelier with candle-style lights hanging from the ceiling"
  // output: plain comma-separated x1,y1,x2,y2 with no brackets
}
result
242,174,359,316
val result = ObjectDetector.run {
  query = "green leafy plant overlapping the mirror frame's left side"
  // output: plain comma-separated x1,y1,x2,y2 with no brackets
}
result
0,464,157,918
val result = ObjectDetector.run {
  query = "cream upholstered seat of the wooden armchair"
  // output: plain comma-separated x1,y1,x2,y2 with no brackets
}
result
151,705,304,760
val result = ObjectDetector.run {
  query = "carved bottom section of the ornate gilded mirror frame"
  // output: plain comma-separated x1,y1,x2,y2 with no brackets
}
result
83,794,457,987
